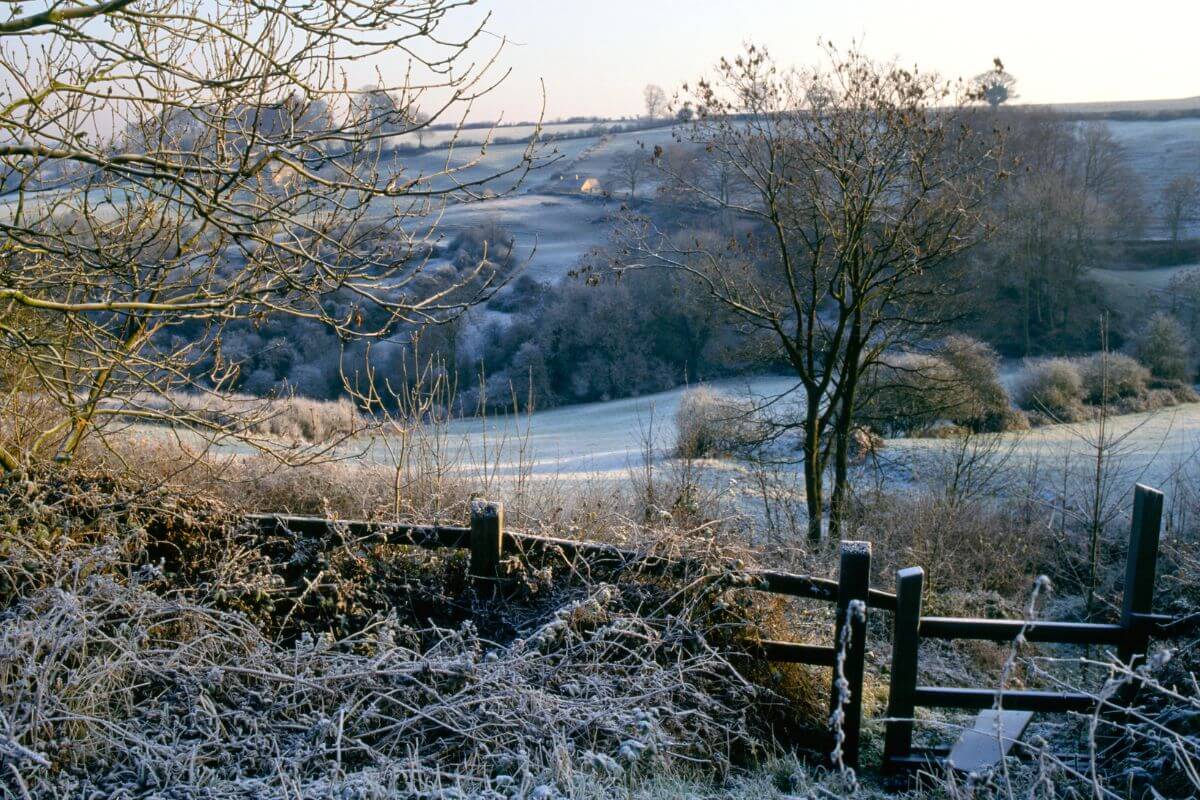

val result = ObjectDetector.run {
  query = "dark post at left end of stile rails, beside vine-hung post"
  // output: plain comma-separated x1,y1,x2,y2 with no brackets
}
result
883,566,925,770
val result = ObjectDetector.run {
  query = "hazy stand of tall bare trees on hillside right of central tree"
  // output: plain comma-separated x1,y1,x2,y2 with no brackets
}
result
964,108,1148,357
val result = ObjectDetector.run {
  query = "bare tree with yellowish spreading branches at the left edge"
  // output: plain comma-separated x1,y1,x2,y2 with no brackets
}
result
0,0,535,470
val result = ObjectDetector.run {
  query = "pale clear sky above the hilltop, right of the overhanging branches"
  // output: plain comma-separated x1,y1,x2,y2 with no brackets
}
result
381,0,1200,121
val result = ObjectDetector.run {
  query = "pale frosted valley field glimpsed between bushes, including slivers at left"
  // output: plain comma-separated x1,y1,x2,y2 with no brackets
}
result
131,366,1200,503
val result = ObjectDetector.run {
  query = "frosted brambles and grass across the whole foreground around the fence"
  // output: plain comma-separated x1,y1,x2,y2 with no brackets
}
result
0,438,1200,799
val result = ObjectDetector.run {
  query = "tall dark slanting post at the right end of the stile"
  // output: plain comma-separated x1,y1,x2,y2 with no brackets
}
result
1117,483,1163,667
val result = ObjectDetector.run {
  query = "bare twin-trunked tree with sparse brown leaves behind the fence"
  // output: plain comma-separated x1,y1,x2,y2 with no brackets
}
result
628,46,996,540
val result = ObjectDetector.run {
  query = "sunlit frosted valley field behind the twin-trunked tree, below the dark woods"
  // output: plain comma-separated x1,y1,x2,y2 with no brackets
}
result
348,371,1200,496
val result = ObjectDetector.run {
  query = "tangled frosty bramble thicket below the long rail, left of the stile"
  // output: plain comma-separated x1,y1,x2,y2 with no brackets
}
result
0,470,827,798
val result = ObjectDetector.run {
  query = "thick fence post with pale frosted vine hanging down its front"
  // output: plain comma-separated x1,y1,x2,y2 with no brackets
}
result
829,542,871,769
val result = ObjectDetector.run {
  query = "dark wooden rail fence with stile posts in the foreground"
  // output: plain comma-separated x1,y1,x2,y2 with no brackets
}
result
250,486,1169,770
